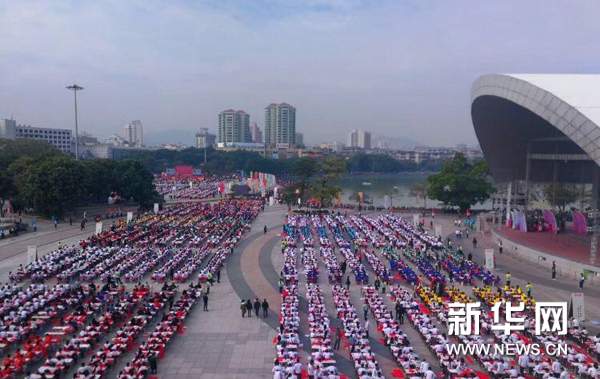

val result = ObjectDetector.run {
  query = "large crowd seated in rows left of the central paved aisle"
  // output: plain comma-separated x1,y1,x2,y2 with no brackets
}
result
0,199,264,379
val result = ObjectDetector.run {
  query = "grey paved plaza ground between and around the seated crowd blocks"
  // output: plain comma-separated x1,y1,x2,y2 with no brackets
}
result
0,206,600,379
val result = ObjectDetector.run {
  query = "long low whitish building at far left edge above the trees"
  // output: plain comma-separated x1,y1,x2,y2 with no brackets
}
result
0,119,74,153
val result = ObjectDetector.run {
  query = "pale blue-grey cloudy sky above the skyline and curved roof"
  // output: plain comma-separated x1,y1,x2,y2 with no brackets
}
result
0,0,600,146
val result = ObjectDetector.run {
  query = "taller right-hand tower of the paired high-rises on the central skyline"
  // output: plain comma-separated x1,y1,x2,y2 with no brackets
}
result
265,103,296,146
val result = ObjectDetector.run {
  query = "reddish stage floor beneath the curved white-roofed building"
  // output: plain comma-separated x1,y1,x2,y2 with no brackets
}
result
494,226,600,267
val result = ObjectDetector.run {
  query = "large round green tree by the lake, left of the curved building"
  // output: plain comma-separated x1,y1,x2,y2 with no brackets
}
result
427,153,495,212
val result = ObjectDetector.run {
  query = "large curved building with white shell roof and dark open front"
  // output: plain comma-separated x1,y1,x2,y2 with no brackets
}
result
471,74,600,207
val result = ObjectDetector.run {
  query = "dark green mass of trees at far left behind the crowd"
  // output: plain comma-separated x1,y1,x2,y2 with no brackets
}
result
0,139,159,216
